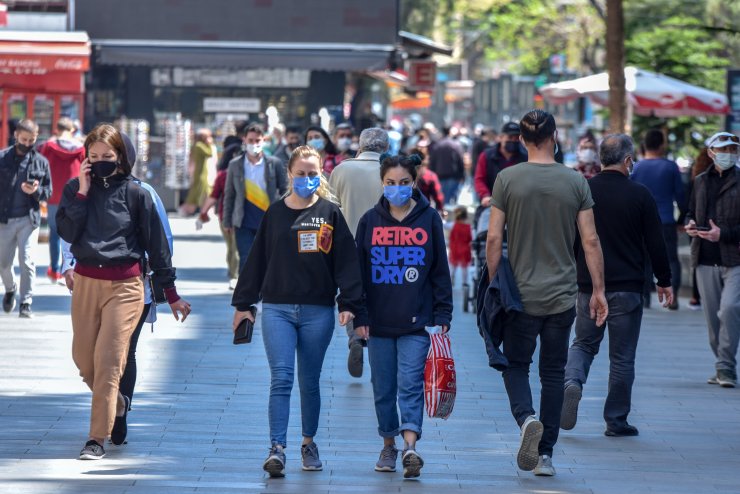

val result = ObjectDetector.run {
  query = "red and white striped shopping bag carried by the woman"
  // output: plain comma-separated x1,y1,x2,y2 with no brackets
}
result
424,333,457,420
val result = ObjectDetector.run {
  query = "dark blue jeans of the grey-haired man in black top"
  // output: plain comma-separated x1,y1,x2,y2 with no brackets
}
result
565,292,642,430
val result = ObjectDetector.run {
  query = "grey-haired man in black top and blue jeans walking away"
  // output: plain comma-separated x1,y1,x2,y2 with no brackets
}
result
560,134,674,436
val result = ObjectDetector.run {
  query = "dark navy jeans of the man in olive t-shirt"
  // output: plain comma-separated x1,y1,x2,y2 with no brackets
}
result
503,308,576,456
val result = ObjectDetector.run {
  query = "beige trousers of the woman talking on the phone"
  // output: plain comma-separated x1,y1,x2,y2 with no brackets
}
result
72,273,144,438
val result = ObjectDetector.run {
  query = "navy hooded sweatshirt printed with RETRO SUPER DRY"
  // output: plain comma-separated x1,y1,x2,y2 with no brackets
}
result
355,190,452,337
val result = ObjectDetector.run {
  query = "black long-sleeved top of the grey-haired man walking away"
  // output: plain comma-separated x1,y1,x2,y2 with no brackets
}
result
576,170,671,293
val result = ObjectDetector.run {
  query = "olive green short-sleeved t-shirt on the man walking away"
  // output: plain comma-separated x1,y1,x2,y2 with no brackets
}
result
491,162,594,316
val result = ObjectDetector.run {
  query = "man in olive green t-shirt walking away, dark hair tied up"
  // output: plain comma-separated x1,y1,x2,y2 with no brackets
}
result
486,110,608,476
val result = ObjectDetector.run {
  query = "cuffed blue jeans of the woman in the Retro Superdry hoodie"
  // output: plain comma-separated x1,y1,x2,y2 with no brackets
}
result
367,335,429,439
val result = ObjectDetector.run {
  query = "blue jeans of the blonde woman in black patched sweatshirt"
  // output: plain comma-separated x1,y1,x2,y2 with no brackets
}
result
262,303,334,447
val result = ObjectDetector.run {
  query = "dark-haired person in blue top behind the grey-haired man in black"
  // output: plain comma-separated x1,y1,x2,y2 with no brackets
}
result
631,129,686,310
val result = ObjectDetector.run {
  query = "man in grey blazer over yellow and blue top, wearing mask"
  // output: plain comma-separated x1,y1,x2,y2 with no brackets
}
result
222,124,288,271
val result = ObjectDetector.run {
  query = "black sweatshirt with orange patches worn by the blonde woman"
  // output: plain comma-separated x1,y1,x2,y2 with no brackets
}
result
231,198,366,316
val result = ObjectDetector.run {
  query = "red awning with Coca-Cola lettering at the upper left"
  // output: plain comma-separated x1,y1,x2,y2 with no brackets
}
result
0,31,90,93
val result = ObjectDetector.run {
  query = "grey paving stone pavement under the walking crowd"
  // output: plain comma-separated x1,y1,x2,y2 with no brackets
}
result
0,219,740,494
